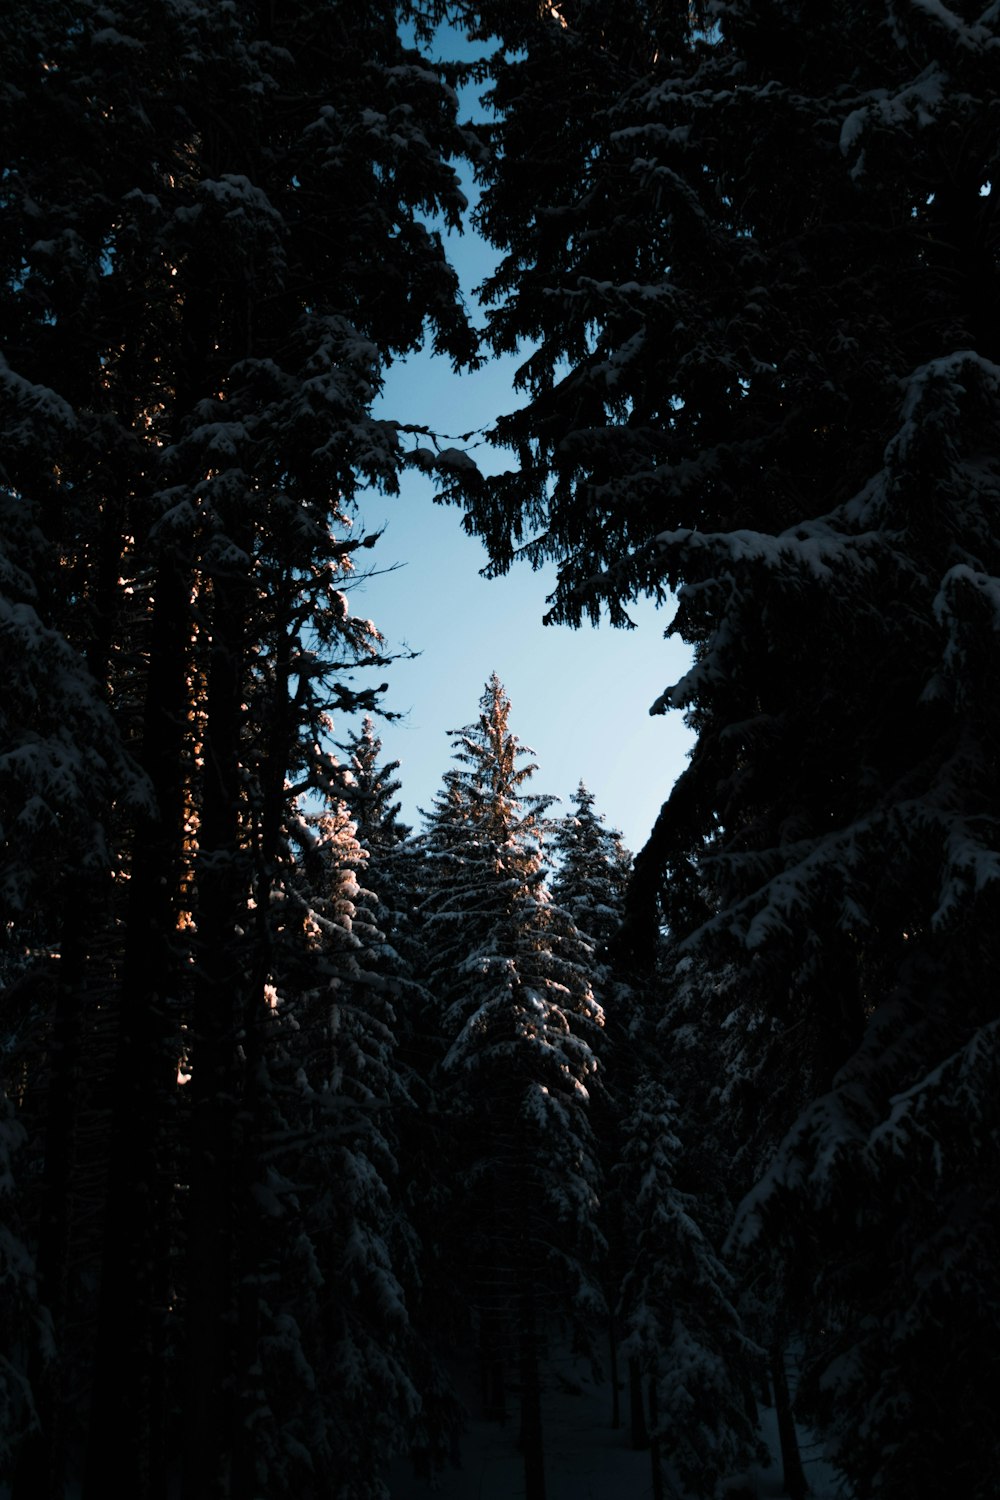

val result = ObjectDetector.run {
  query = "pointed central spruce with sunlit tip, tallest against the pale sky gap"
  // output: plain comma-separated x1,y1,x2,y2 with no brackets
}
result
421,674,603,1497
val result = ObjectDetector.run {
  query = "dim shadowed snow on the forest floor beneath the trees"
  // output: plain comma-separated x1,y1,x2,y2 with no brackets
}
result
390,1362,843,1500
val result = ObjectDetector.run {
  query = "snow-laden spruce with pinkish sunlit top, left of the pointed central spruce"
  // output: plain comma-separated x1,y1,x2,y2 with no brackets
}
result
247,801,429,1500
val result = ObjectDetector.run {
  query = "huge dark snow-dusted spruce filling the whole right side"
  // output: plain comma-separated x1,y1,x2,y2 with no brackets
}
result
446,0,1000,1500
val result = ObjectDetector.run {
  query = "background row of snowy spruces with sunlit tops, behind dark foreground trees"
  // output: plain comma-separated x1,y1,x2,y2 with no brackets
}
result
3,639,761,1500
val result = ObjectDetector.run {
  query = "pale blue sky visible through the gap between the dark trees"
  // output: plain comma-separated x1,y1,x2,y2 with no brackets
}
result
340,23,693,851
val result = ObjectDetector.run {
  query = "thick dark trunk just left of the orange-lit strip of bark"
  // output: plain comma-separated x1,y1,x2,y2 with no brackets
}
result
84,561,190,1500
